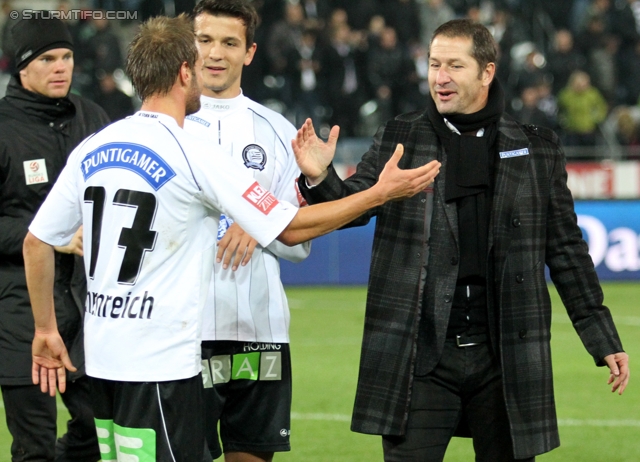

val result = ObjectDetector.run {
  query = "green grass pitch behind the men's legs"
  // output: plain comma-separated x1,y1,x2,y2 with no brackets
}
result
0,283,640,462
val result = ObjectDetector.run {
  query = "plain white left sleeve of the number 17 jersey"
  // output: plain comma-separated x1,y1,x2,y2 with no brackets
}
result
29,149,82,246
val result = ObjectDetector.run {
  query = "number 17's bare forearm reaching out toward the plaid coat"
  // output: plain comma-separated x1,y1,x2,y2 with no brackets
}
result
278,182,387,245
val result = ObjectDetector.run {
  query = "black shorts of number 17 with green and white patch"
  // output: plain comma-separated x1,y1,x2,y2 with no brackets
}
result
91,374,211,462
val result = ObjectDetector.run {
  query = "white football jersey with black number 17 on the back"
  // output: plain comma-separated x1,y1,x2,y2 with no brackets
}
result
29,112,297,382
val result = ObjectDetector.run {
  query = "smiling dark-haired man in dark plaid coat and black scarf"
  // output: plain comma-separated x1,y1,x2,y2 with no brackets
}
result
293,20,629,462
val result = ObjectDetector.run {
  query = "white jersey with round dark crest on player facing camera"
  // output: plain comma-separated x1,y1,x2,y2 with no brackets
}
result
184,94,311,343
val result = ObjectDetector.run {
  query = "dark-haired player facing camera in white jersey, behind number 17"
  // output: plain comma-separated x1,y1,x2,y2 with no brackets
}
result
184,0,311,462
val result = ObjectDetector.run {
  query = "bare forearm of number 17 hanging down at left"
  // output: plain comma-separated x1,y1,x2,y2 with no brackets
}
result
23,232,57,331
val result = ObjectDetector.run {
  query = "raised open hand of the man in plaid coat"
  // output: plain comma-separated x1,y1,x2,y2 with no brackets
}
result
291,119,340,185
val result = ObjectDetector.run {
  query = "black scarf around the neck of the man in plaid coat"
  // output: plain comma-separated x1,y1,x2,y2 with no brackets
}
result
427,79,504,283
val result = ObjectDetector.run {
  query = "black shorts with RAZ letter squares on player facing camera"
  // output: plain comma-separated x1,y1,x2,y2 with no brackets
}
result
202,341,291,458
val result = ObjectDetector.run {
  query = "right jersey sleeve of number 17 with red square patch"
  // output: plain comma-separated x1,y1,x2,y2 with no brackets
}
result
190,143,298,247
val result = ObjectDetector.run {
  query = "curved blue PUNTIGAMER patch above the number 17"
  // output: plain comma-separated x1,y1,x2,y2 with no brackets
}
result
80,143,176,191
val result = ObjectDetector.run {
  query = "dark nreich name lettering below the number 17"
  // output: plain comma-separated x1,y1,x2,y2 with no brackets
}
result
84,290,154,319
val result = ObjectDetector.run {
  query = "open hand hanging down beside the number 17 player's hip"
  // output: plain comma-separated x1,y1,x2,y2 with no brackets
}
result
31,330,77,396
